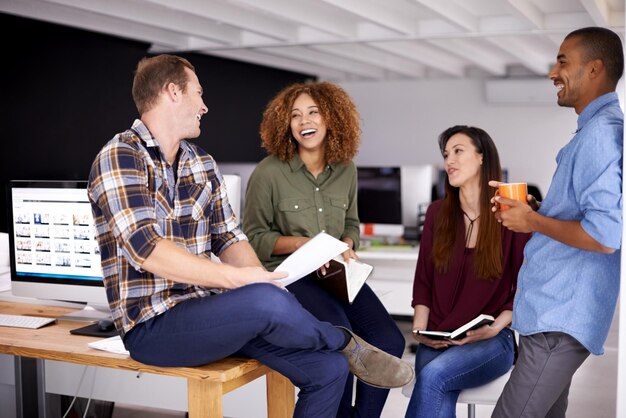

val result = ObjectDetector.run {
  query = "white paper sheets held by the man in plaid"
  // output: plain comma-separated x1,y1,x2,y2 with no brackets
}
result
274,232,348,286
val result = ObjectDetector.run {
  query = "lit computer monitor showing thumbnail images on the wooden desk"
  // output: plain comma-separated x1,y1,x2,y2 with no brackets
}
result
7,180,110,321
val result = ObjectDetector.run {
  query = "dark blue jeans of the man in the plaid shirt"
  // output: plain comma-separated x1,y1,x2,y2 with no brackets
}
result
124,283,349,418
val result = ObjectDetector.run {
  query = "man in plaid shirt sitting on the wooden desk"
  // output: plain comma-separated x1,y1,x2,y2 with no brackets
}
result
88,55,413,418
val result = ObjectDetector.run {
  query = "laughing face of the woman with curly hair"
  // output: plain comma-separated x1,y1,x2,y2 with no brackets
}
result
291,93,326,152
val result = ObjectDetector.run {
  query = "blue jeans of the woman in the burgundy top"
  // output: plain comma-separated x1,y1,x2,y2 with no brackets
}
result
405,328,515,418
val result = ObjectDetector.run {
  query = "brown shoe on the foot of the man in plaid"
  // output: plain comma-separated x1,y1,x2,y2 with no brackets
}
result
337,327,415,388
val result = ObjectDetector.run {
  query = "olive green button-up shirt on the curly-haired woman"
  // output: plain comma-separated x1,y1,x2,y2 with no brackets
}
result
243,154,359,271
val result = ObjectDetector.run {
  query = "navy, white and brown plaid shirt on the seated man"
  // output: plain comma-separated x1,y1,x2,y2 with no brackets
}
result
88,120,247,334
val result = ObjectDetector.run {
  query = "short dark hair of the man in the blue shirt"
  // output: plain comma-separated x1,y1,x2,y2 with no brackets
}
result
565,26,624,87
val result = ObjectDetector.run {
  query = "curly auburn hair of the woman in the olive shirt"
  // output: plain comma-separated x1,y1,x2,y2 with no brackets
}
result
259,82,361,164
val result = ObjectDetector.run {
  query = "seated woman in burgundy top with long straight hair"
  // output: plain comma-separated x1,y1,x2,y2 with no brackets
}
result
406,126,530,418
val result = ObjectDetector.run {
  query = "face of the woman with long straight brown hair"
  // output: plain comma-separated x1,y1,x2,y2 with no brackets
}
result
443,133,483,187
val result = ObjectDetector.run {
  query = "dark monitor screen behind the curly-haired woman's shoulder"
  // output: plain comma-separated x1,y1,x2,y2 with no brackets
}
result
357,167,402,225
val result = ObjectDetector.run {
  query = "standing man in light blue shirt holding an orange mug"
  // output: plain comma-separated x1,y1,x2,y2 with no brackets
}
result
492,27,624,418
